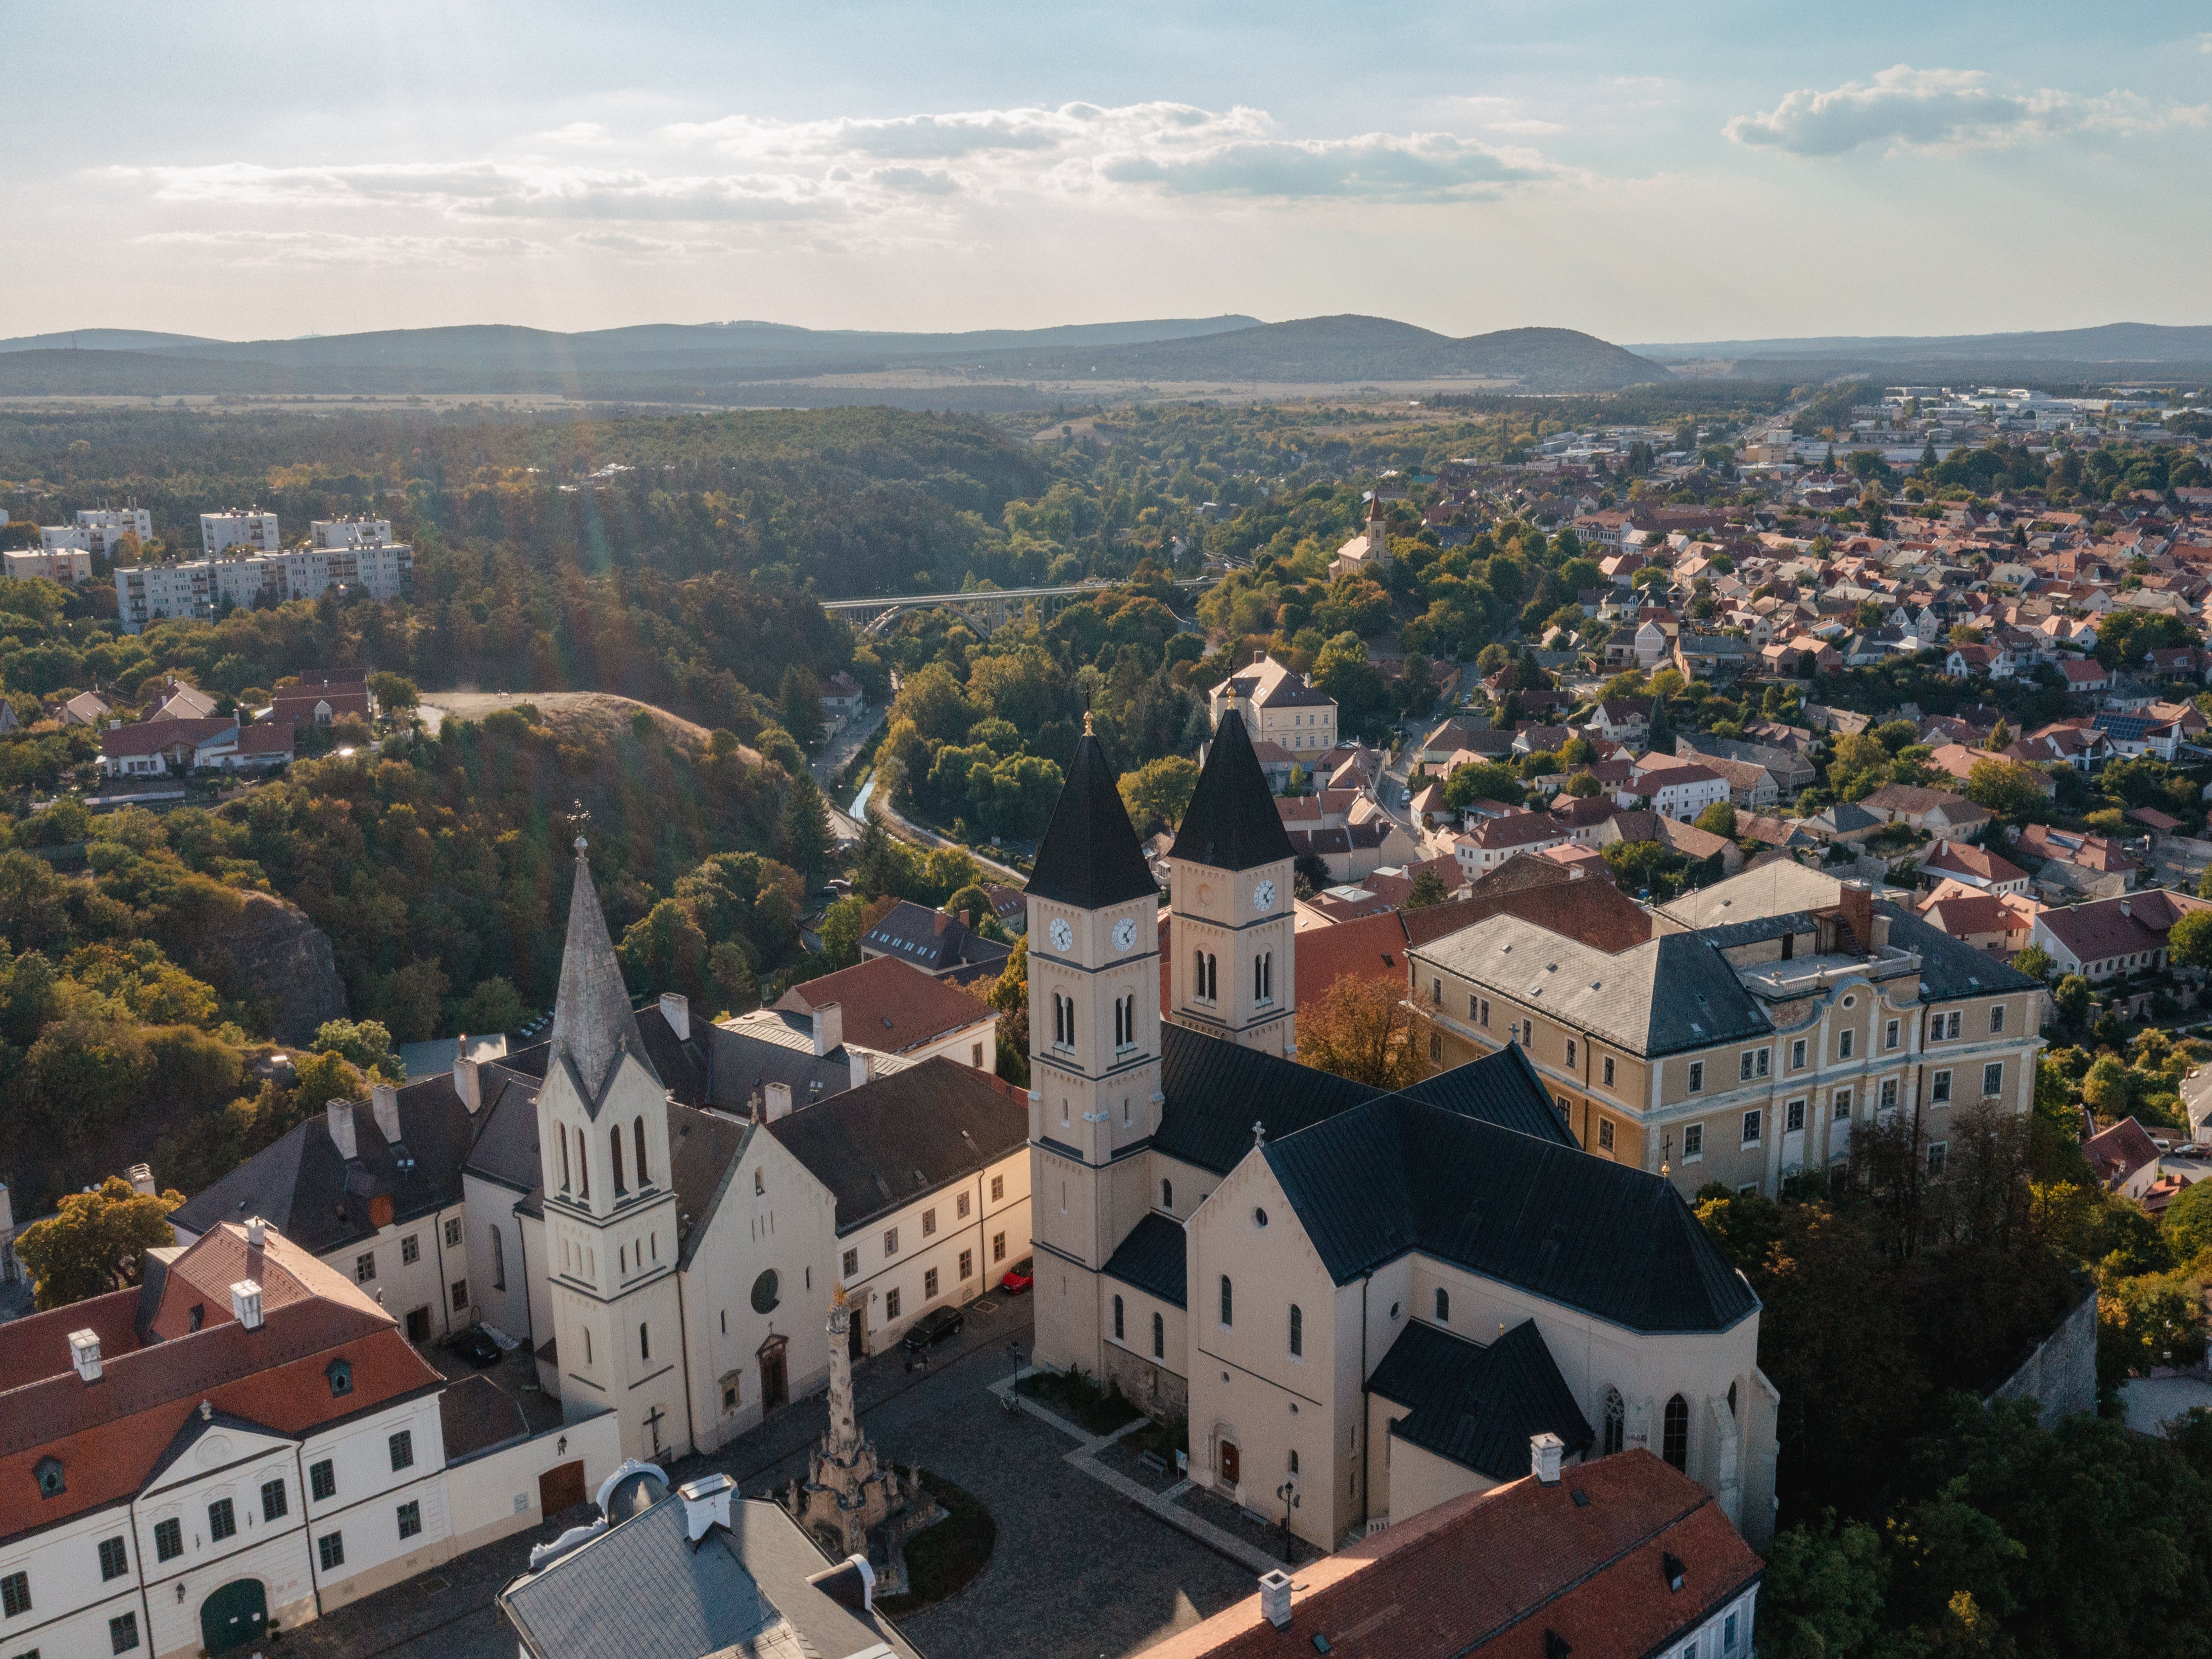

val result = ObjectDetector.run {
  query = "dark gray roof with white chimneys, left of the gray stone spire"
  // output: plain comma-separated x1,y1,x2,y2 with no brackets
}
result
173,1073,476,1257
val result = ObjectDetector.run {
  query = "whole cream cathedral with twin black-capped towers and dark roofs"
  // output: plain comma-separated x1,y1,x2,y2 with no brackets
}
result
1029,710,1778,1549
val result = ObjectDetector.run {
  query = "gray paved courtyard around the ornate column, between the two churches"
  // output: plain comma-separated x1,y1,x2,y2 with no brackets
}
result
283,1296,1254,1659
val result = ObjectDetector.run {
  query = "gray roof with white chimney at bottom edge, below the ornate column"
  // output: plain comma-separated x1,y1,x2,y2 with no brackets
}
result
500,1498,914,1659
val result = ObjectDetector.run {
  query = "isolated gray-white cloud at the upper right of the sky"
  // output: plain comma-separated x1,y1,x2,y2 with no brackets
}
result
1721,64,2206,155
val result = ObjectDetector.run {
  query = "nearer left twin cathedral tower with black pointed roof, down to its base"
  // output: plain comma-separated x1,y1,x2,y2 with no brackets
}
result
1029,719,1164,1374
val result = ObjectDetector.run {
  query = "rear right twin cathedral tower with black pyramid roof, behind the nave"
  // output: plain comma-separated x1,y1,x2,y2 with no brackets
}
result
1168,708,1298,1055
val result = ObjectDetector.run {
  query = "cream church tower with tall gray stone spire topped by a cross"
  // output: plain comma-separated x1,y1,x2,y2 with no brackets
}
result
538,836,690,1458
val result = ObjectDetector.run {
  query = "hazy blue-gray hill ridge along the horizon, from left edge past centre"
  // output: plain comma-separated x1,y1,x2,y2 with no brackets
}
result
0,316,1670,401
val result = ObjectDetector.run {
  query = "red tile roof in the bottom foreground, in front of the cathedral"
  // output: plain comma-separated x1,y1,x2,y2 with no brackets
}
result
1148,1451,1765,1659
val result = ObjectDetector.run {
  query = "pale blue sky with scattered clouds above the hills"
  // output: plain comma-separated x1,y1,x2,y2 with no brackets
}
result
0,0,2212,343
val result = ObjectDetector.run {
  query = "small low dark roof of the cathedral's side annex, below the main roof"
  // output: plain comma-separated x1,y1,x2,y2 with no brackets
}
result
1367,1318,1597,1480
